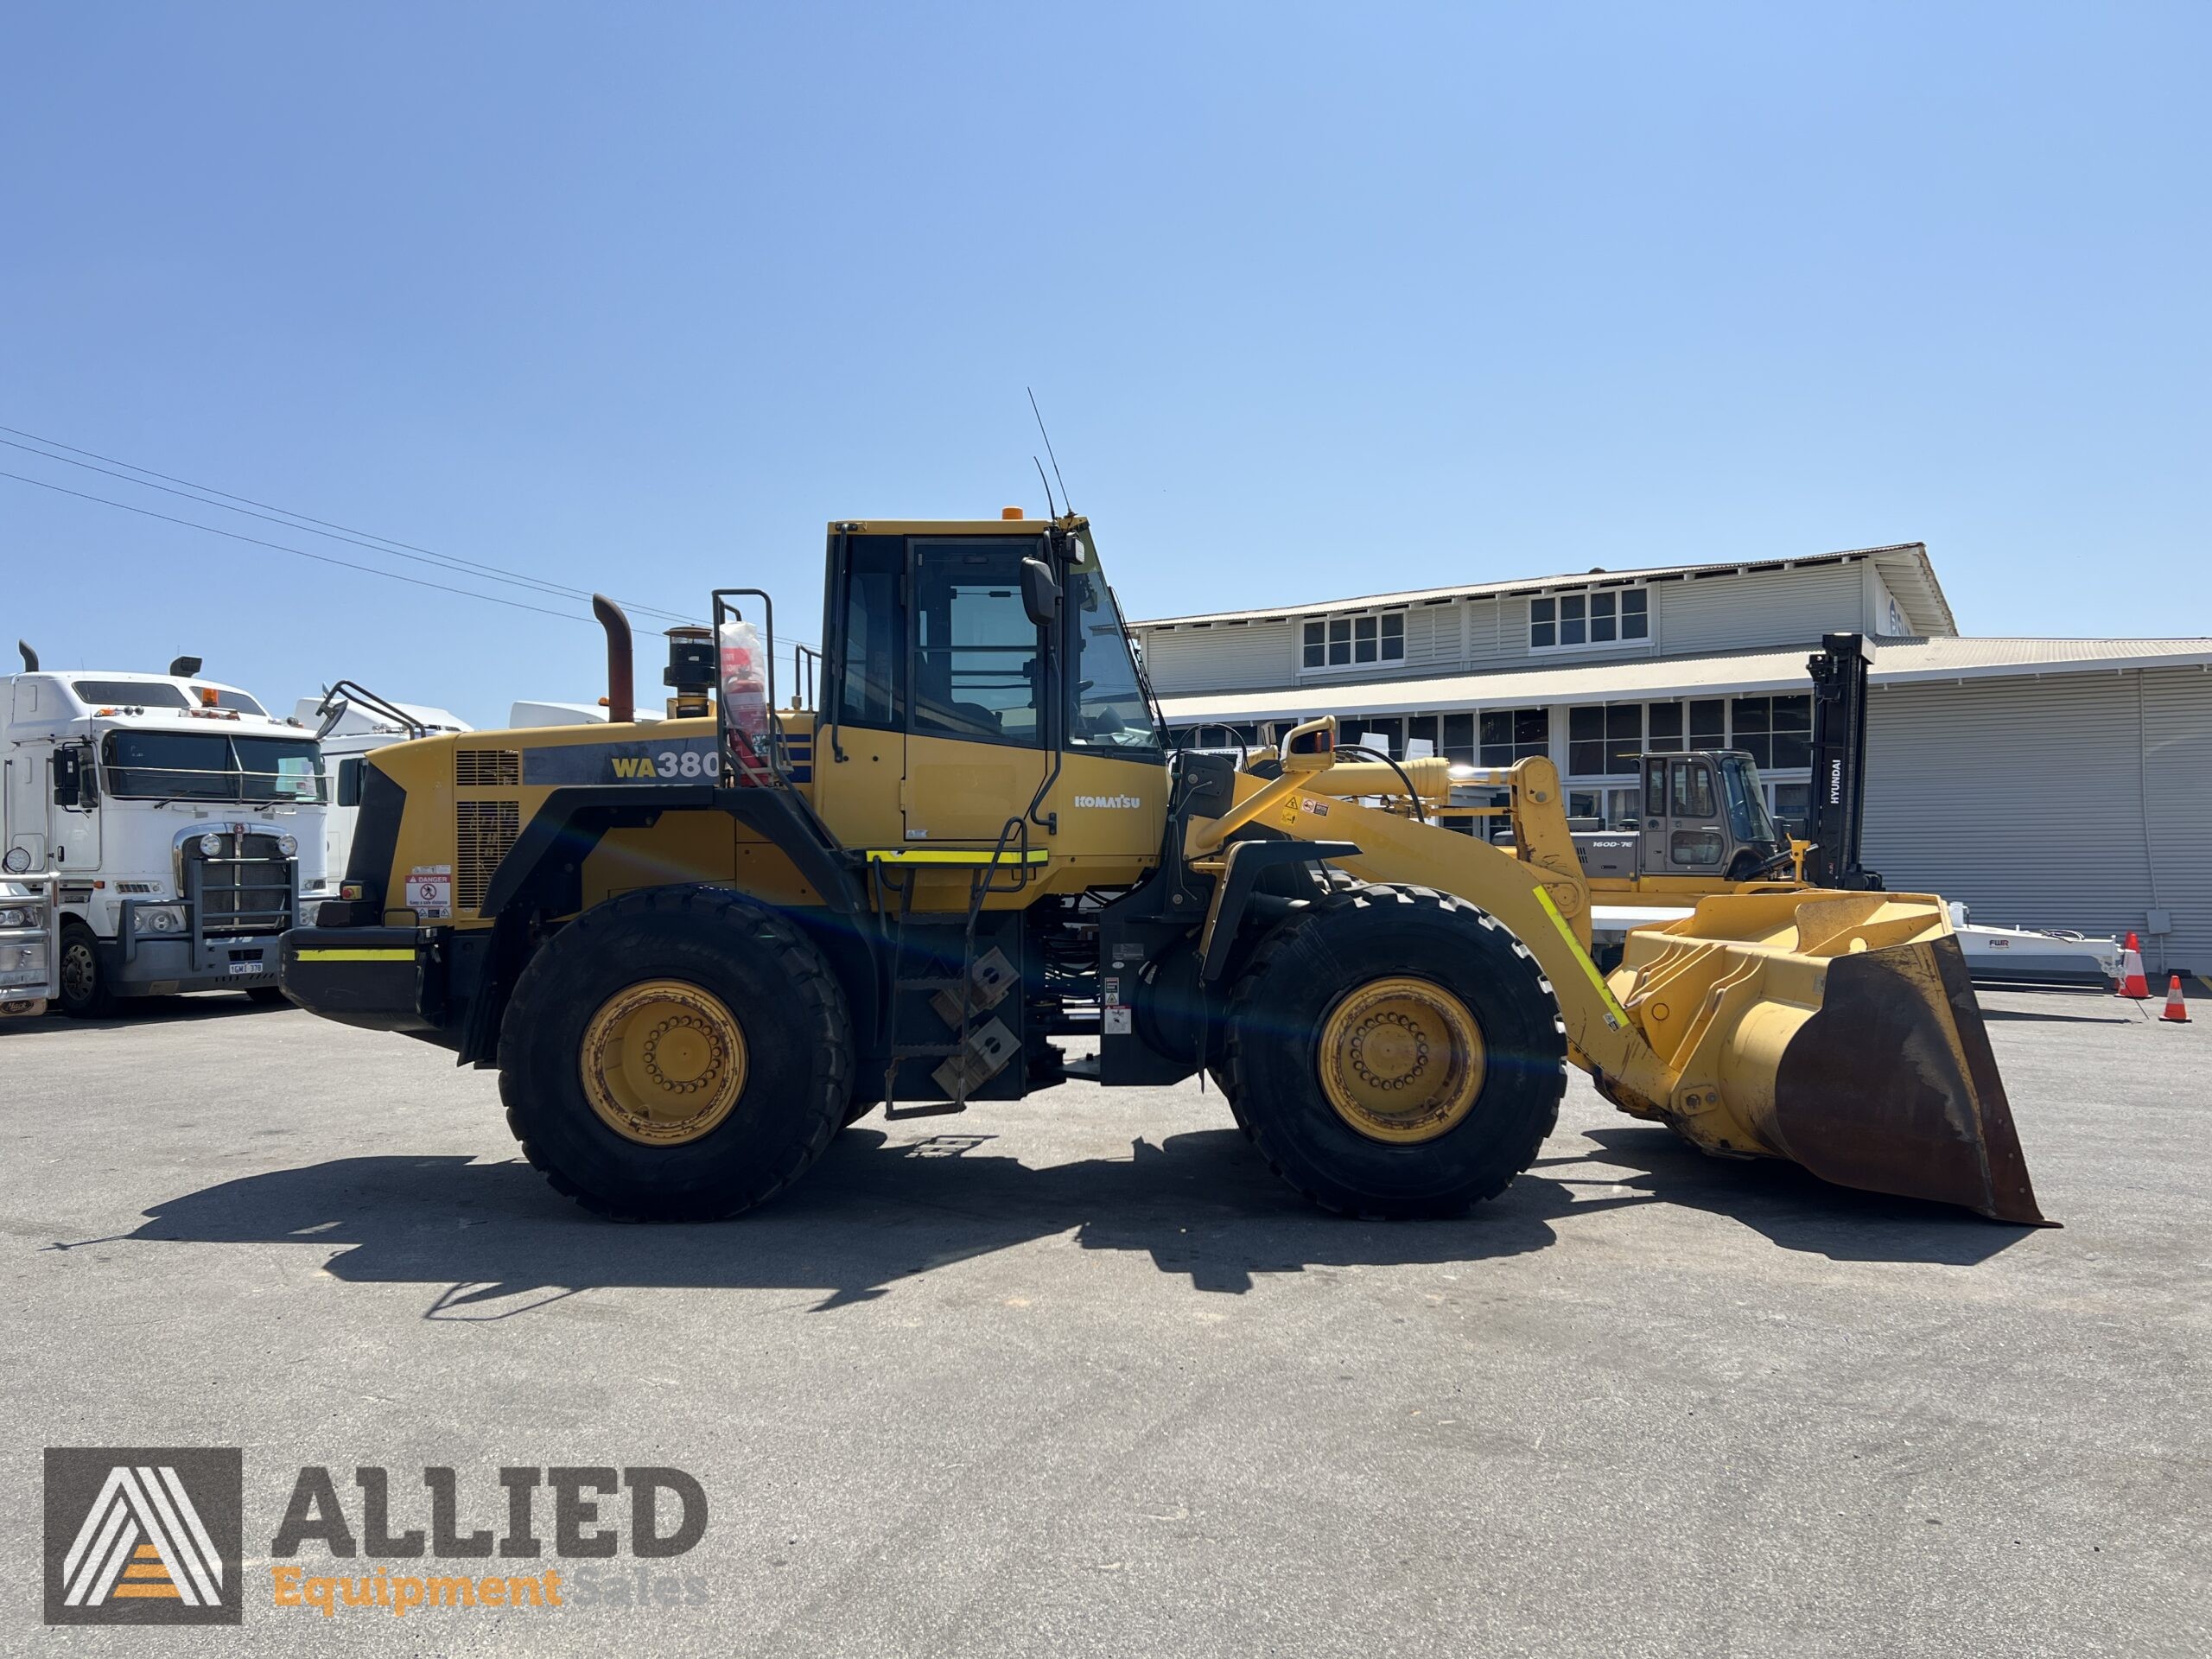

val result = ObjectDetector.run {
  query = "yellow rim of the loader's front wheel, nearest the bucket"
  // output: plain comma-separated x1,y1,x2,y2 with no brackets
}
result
1319,978,1484,1146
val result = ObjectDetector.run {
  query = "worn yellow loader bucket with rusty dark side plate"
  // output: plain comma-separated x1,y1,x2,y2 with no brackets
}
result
1612,892,2050,1225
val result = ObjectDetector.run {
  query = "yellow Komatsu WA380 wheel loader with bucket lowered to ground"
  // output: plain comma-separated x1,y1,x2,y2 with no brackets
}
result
283,519,2042,1224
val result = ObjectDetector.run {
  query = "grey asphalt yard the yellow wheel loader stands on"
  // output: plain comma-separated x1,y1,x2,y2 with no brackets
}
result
0,991,2212,1659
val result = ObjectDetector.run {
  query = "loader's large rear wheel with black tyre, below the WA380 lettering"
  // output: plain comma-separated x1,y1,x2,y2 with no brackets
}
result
500,887,854,1221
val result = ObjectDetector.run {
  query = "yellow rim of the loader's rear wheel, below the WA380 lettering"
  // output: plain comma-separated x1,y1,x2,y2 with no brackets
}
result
582,980,746,1146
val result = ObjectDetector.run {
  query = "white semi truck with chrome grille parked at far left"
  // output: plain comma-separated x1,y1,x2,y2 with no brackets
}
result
0,646,329,1018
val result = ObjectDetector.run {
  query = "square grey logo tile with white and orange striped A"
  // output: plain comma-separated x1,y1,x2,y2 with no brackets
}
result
47,1446,245,1624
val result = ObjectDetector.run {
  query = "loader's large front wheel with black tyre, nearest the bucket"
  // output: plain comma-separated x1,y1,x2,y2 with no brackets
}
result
1228,885,1566,1219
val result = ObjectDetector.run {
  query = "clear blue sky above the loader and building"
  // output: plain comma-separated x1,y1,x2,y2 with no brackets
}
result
0,4,2212,723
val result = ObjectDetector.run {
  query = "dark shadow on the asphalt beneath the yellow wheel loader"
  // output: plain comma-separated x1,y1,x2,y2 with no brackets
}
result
69,1110,2029,1319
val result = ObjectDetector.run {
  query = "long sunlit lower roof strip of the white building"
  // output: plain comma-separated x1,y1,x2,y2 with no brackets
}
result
1161,637,2212,721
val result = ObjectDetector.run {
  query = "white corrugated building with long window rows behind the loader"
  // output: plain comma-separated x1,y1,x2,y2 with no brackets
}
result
1133,542,2212,973
